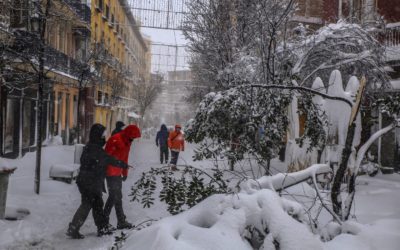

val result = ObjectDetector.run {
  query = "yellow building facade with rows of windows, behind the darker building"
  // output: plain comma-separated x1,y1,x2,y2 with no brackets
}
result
91,0,150,133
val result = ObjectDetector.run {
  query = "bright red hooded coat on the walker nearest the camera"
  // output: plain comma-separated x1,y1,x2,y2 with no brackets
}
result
106,125,141,176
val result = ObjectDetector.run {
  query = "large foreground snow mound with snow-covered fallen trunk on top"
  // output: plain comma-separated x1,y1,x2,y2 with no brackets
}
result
125,164,330,250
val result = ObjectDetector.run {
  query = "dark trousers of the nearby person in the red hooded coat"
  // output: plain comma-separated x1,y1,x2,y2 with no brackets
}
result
104,176,126,223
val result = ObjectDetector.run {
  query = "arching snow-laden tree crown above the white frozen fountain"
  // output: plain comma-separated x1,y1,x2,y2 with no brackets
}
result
288,20,388,90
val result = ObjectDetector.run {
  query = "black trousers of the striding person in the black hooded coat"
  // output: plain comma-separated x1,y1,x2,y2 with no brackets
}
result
70,185,107,231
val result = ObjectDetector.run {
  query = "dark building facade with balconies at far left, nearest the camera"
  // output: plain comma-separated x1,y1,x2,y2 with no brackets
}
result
0,0,90,157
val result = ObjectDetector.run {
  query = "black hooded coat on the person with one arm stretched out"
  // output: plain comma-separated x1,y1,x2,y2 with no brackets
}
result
76,124,128,195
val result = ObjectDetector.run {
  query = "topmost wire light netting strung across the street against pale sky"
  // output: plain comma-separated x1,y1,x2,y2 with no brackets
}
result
128,0,190,30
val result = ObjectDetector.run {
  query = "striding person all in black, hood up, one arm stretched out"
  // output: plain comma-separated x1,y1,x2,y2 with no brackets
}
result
67,124,129,239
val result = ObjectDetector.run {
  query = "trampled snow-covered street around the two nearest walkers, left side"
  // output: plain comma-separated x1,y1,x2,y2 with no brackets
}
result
0,140,200,250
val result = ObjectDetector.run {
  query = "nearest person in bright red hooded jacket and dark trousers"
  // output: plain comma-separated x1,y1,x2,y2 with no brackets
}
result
104,125,141,229
